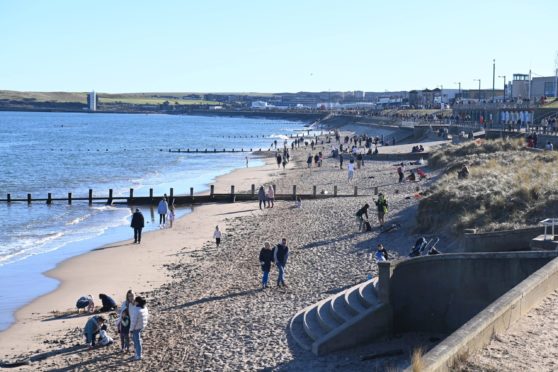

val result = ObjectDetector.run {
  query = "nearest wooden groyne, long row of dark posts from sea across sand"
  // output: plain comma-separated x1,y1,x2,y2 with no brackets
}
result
0,184,372,206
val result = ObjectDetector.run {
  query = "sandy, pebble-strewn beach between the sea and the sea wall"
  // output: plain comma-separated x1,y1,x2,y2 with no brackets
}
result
0,130,554,371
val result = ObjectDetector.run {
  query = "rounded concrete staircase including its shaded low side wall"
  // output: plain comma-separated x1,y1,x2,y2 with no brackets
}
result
289,278,393,355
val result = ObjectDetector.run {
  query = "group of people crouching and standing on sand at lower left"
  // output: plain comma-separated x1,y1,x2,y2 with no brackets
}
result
76,290,149,360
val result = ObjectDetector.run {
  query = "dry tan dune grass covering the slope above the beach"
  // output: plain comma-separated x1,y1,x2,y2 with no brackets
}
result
416,140,558,234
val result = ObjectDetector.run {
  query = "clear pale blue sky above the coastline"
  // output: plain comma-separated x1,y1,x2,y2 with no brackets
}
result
0,0,558,92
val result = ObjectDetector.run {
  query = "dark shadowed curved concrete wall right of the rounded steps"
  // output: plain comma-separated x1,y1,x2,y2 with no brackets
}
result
380,252,558,334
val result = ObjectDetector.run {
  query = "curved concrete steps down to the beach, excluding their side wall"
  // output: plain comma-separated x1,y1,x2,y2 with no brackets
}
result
289,278,392,353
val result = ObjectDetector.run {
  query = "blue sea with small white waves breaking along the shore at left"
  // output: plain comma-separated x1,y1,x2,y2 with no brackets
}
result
0,112,314,331
